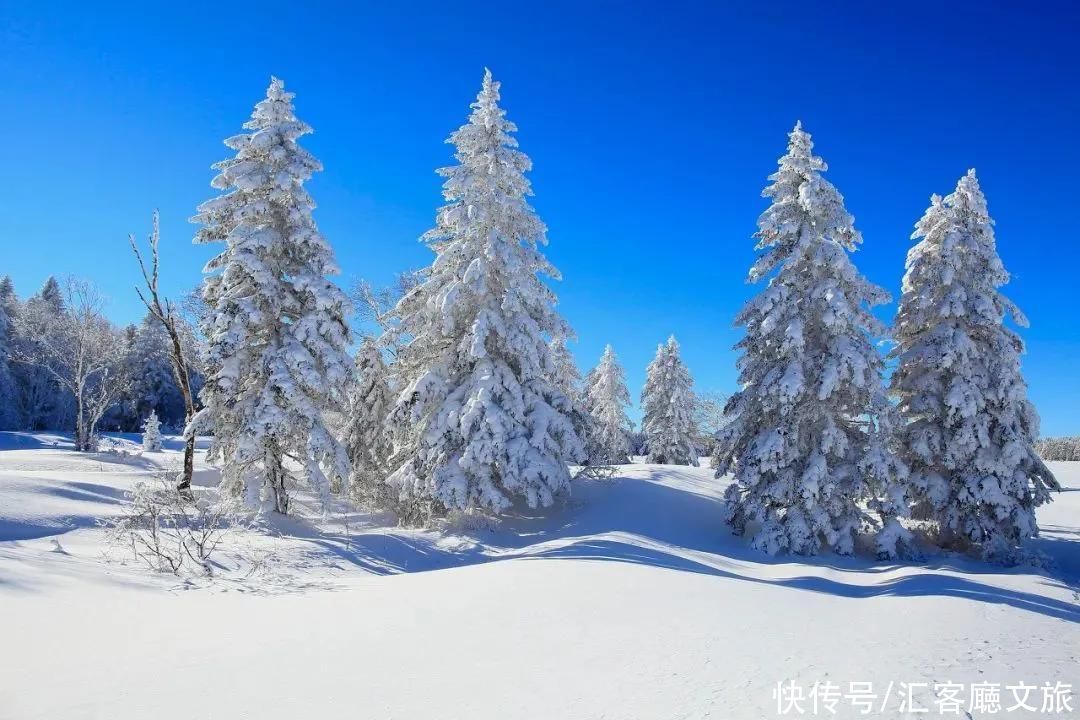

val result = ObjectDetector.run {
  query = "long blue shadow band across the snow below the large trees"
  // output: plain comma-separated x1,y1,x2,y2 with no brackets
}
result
267,468,1080,622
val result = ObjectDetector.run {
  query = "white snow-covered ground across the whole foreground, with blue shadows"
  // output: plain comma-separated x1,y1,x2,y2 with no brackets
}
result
0,433,1080,720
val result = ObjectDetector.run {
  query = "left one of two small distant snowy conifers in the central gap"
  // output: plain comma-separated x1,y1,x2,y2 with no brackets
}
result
585,345,634,465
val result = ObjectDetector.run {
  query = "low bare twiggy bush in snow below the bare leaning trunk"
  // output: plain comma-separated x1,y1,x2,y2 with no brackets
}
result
104,472,232,575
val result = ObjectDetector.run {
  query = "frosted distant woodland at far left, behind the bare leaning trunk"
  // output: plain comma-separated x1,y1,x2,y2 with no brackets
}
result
0,276,203,450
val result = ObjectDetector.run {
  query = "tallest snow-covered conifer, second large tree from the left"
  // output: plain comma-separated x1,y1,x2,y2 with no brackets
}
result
388,71,582,522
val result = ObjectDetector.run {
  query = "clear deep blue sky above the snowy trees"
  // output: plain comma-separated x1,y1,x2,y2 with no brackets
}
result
0,1,1080,434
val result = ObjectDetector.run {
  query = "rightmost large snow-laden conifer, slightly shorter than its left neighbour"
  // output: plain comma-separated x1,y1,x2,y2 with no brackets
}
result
892,171,1059,562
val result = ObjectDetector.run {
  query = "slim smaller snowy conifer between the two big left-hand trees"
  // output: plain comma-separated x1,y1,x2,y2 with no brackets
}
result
345,338,393,506
